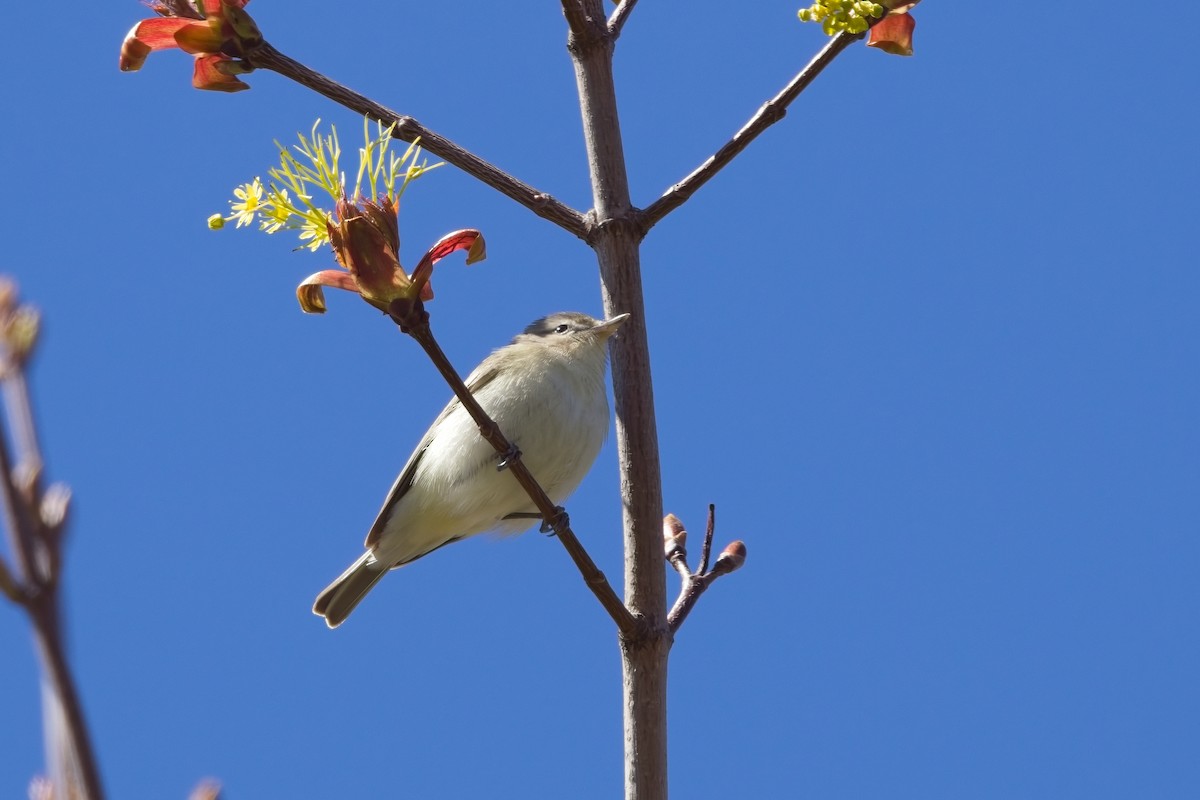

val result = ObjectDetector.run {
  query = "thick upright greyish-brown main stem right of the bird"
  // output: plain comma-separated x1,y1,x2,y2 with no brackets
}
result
569,7,671,800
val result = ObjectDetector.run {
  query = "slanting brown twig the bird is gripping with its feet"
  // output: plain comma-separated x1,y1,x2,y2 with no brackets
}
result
390,301,637,634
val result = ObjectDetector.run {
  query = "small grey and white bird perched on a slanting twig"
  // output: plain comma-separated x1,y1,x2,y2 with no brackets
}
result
312,312,629,627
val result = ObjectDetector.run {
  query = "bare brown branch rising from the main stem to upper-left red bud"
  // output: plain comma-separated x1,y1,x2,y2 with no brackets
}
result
246,42,588,239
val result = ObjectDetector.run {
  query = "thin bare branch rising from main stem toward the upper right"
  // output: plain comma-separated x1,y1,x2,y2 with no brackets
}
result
638,32,863,233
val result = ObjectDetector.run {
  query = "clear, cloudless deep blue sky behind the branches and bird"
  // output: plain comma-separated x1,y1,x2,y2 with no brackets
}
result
0,0,1200,800
